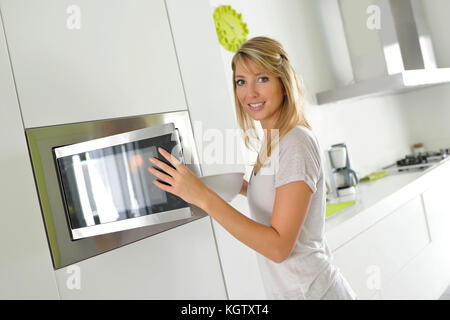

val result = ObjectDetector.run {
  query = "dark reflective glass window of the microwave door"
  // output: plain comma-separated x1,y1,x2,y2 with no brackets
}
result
57,134,188,229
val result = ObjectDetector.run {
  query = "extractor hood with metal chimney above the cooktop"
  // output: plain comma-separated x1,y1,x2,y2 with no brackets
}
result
317,0,450,104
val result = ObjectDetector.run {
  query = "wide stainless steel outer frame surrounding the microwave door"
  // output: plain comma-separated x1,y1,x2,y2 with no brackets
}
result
26,110,207,269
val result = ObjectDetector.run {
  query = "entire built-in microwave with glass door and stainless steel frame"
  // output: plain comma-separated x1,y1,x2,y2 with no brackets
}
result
26,111,206,269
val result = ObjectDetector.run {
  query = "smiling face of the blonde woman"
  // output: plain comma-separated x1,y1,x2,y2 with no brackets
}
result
234,60,284,129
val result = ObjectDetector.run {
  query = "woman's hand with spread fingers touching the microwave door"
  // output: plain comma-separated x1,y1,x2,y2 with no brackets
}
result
148,148,211,208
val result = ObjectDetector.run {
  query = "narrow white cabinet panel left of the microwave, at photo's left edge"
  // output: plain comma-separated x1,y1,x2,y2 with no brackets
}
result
0,13,59,300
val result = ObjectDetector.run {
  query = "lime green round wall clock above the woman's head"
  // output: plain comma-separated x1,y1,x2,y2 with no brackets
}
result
214,5,248,52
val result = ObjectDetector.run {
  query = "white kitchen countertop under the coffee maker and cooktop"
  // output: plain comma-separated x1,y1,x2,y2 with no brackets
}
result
325,158,450,251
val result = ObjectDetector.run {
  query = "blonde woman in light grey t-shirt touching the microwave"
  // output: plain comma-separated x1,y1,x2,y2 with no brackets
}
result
149,37,355,299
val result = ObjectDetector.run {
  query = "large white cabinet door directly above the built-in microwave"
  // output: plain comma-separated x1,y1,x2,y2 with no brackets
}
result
0,0,187,128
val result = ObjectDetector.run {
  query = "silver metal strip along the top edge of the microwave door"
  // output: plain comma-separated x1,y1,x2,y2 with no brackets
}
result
54,123,175,159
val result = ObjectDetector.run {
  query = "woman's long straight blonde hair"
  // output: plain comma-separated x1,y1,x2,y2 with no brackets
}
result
231,37,311,168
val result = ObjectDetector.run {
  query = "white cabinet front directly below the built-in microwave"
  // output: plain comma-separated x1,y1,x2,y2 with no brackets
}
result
55,218,226,300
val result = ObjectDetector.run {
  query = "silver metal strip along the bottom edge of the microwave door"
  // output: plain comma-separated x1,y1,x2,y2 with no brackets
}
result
72,207,192,240
